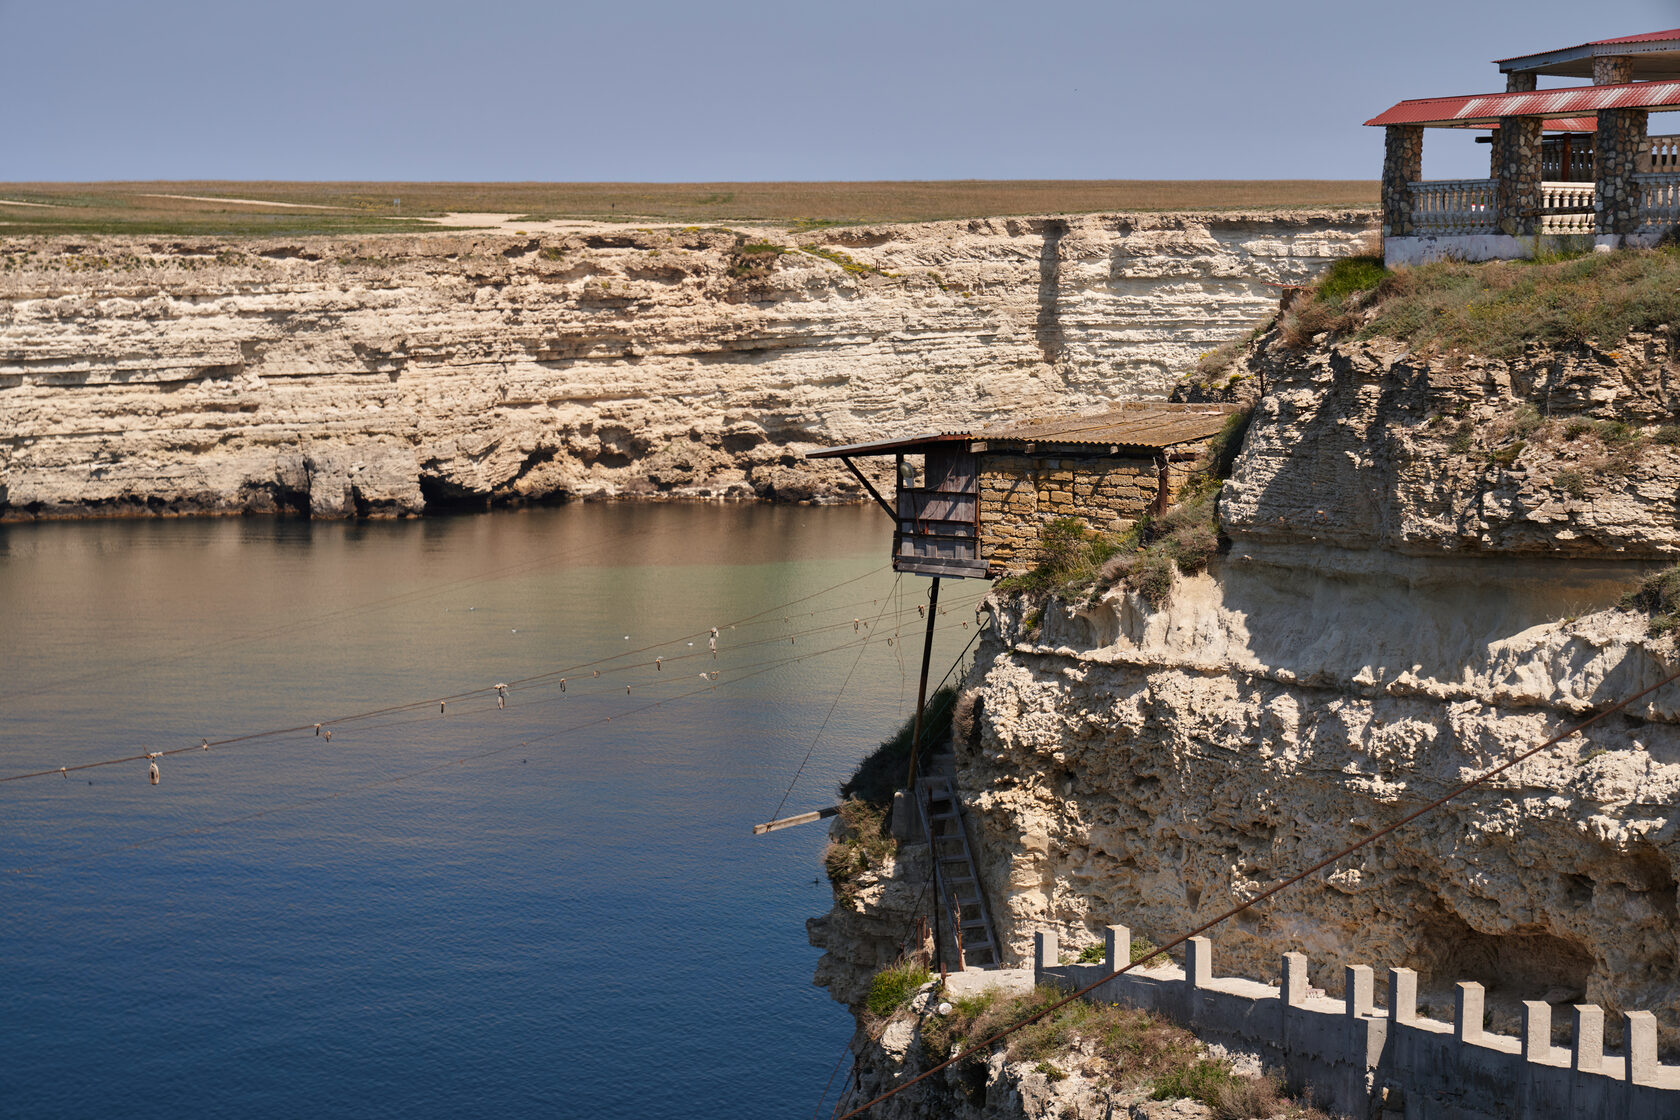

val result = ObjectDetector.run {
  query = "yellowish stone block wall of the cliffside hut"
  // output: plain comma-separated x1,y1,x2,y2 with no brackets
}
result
979,443,1206,574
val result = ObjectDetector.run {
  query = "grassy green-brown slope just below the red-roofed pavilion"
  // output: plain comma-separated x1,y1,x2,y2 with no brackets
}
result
1280,245,1680,359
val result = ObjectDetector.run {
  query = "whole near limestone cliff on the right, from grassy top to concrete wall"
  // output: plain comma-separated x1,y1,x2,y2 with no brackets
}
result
819,317,1680,1074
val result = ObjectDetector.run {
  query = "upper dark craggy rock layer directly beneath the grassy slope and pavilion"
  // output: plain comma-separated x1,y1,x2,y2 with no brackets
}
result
1220,336,1680,559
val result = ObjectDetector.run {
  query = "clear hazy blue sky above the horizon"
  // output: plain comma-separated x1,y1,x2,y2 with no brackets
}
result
0,0,1680,181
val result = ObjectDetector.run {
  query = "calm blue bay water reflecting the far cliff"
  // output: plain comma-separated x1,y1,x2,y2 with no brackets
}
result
0,505,979,1118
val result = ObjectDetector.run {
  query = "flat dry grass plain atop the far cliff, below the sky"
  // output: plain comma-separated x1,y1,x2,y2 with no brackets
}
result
0,180,1378,237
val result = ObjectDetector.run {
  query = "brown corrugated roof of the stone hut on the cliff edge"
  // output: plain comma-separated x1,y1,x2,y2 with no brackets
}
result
806,401,1230,458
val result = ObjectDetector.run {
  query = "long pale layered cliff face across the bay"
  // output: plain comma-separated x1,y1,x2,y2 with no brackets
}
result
0,212,1373,517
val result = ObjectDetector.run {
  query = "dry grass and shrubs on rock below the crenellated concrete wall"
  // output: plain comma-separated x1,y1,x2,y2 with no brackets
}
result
921,987,1317,1120
